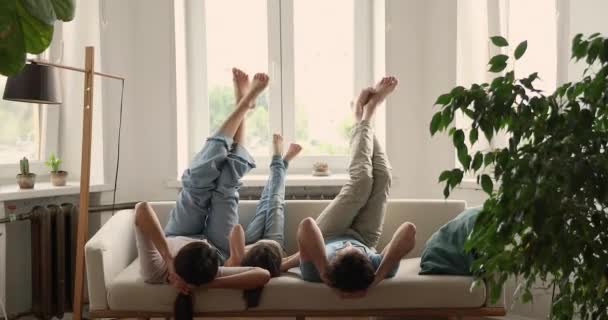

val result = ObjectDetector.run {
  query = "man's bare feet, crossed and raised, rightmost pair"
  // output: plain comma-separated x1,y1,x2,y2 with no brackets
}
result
354,76,399,122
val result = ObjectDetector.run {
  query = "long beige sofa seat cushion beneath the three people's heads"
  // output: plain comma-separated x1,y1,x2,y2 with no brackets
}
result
108,258,486,312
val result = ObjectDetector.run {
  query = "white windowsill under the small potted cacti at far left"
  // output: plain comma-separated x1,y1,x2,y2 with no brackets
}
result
0,181,114,201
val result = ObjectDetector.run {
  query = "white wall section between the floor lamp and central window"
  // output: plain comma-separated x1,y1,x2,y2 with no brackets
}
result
95,0,177,202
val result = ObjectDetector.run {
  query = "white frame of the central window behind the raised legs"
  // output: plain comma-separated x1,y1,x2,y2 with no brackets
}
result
175,0,384,177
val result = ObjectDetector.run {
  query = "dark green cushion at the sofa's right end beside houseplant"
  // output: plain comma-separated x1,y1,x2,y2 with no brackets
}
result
420,207,481,275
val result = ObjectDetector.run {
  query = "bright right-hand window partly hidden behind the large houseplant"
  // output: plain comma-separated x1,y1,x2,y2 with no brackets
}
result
455,0,557,178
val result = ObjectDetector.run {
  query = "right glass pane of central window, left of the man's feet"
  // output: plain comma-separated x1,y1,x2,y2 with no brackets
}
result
293,0,355,155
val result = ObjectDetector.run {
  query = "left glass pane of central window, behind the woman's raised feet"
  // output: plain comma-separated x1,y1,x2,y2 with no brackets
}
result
205,0,270,155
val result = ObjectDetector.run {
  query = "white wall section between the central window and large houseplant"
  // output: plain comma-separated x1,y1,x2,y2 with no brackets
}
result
386,0,456,198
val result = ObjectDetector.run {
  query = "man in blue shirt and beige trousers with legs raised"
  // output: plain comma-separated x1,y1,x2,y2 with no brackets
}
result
282,77,416,298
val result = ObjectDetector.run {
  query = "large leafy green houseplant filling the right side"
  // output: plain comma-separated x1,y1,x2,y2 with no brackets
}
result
430,34,608,319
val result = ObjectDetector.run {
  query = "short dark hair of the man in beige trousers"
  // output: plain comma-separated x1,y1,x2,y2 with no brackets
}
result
325,250,375,292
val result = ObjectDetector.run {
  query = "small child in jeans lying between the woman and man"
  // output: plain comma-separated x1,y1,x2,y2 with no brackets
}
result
224,134,302,308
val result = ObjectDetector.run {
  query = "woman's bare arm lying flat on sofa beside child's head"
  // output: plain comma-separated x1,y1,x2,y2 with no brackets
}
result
203,267,270,290
